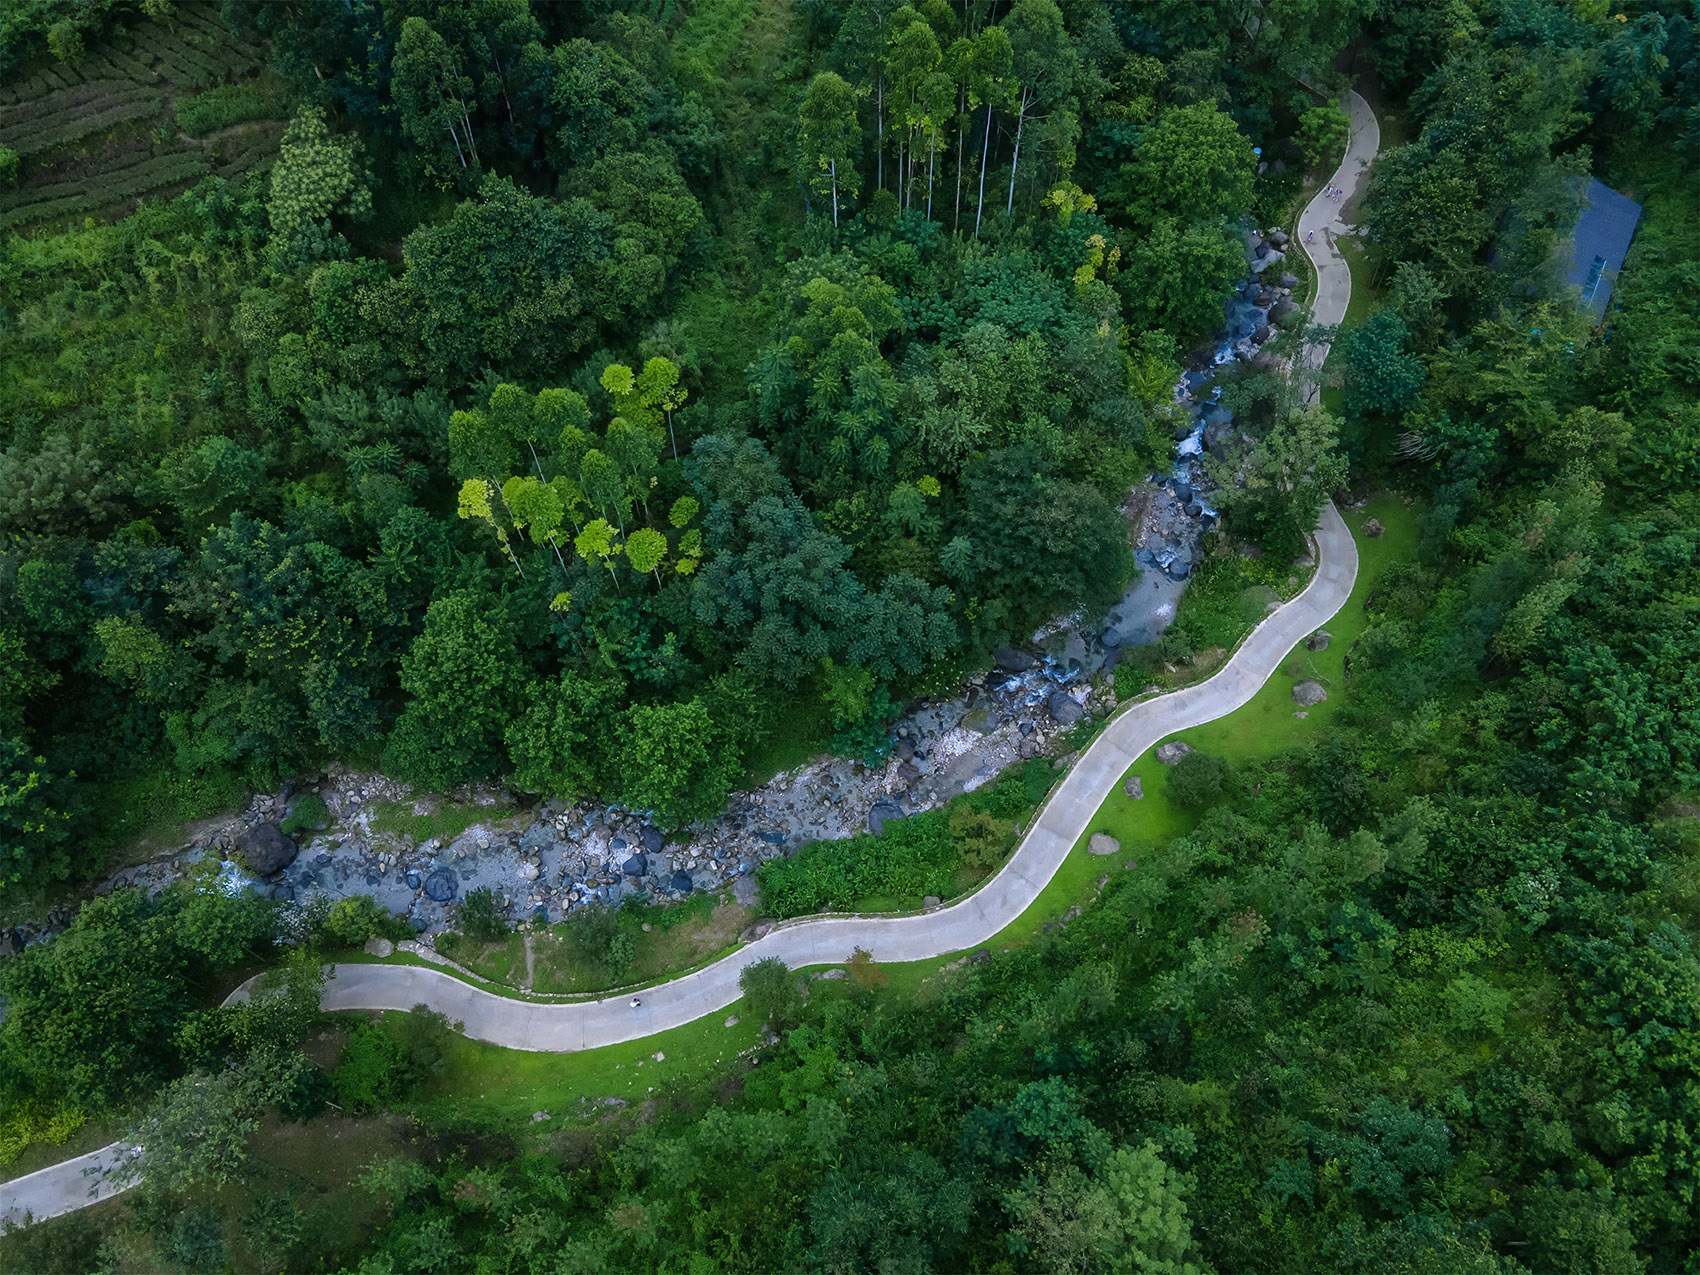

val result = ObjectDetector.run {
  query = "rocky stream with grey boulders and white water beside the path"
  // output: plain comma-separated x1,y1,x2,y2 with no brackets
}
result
0,230,1304,947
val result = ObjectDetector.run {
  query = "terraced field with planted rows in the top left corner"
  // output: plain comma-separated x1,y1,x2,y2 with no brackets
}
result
0,0,287,231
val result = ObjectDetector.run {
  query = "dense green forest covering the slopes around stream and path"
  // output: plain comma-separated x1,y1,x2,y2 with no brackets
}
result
0,0,1700,1272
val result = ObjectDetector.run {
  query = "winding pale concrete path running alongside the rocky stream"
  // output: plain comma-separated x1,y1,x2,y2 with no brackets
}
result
0,92,1380,1222
